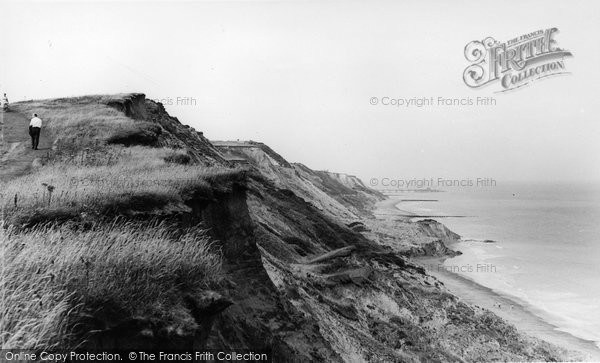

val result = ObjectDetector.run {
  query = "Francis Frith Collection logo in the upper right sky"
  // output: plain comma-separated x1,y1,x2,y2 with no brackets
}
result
463,28,572,92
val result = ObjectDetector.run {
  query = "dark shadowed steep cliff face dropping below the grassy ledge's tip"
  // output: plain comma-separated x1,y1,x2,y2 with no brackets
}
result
183,181,338,362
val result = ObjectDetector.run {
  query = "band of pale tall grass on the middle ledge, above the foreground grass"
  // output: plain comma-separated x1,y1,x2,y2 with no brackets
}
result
0,146,243,226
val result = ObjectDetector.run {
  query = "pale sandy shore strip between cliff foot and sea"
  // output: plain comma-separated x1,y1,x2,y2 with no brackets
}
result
375,197,600,362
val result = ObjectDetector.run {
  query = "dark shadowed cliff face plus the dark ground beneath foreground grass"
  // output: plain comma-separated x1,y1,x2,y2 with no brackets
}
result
75,173,341,362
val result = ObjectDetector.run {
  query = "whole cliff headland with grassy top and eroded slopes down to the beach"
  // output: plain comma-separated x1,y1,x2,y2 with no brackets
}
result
0,94,560,362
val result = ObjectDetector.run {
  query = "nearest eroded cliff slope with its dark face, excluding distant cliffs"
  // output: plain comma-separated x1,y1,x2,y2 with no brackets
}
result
193,173,558,362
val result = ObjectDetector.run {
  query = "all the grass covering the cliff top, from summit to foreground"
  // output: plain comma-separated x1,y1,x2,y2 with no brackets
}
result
0,96,237,349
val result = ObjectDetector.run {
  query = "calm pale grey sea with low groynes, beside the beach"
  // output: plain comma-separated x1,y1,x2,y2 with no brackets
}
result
397,183,600,347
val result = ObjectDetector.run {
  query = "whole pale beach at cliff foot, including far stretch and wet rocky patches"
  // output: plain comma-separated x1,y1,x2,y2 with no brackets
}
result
375,193,600,361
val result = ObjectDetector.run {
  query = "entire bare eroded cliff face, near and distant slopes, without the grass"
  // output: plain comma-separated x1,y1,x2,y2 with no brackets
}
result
82,95,560,362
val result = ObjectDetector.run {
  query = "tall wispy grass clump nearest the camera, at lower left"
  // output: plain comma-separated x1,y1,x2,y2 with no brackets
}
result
0,219,222,349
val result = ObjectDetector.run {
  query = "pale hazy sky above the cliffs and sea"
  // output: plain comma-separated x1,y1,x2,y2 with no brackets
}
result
0,0,600,183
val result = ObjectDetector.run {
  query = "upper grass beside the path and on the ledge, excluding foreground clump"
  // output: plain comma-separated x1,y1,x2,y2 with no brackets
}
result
0,96,242,226
